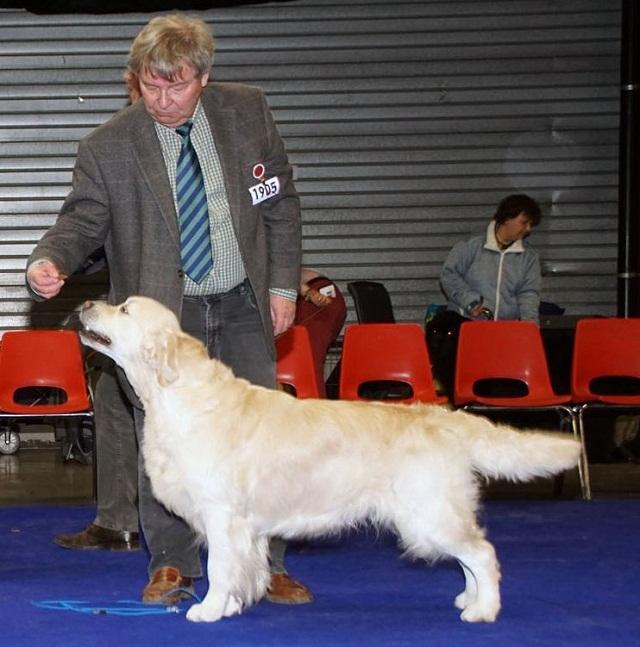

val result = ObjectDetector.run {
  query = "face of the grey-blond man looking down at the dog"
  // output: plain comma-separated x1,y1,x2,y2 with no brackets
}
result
139,65,209,128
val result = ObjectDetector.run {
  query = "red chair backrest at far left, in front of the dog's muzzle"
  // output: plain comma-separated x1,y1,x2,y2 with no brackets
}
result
0,330,91,415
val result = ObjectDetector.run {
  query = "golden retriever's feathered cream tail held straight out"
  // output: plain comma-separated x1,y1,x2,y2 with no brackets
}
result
469,420,580,481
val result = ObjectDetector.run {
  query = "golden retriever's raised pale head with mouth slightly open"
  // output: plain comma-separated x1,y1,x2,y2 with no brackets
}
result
80,296,198,395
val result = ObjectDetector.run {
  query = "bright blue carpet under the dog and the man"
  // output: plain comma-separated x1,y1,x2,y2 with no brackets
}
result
0,500,640,647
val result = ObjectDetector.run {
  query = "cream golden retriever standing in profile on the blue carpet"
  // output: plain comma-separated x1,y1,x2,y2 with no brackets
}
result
80,296,580,622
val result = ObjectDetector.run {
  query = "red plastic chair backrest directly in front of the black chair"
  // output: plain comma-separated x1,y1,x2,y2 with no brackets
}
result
340,323,447,404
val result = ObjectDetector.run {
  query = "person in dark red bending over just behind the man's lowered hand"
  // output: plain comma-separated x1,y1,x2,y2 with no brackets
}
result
295,267,347,397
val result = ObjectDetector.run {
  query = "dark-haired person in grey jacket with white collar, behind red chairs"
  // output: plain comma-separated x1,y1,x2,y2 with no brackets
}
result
427,194,542,396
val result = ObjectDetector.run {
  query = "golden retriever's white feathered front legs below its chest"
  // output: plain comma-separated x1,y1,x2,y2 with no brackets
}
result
187,514,269,622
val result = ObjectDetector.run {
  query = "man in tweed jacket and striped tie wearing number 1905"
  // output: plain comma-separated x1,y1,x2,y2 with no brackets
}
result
27,15,311,604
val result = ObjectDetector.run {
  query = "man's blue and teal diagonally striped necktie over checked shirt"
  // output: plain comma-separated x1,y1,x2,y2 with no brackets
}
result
176,122,213,283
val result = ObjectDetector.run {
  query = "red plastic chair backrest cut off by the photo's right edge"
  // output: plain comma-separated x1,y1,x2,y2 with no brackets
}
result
571,317,640,405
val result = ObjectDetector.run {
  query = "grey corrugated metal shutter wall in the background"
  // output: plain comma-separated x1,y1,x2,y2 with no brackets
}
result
0,0,620,329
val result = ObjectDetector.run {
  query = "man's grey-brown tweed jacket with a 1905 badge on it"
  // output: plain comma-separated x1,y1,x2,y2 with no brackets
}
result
29,83,301,356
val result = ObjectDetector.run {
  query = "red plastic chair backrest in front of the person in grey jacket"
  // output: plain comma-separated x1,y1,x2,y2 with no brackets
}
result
454,320,569,407
